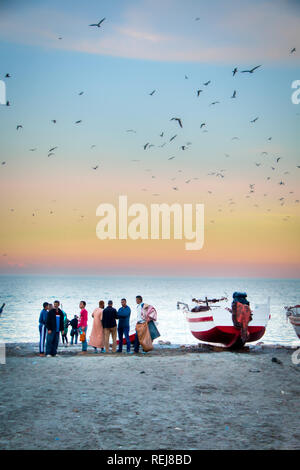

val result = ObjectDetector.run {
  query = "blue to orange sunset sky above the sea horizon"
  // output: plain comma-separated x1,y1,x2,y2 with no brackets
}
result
0,0,300,278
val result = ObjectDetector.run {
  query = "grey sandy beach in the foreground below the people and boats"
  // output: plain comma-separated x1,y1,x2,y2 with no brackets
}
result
0,344,300,450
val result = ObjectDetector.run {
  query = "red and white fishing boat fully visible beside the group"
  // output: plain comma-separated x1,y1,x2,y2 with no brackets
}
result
177,293,271,349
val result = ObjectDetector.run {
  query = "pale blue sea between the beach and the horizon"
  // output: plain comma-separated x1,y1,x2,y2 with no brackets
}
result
0,275,300,346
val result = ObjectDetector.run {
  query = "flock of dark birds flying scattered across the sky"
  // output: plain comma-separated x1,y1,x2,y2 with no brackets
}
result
1,17,300,231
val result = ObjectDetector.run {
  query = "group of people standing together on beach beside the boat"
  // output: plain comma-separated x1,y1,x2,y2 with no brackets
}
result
39,295,160,357
